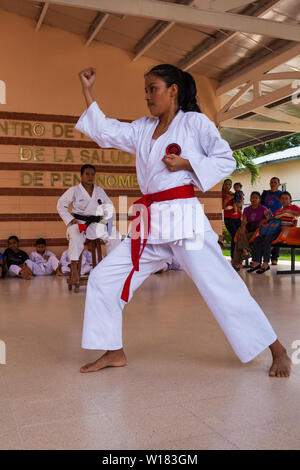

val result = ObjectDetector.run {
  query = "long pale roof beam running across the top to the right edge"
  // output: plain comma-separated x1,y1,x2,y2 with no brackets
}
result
45,0,300,42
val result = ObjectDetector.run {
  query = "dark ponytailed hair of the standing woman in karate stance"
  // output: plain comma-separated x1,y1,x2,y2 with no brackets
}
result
145,64,201,113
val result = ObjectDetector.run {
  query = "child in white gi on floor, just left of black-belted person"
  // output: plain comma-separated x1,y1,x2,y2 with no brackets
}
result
29,238,59,276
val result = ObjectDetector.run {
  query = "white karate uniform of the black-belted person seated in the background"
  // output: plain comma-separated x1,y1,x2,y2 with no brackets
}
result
57,183,120,261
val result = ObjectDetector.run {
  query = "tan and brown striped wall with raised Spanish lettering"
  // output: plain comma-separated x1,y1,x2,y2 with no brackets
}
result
0,10,225,254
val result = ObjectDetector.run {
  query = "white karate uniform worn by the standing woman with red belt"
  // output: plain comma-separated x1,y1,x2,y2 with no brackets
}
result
76,101,276,362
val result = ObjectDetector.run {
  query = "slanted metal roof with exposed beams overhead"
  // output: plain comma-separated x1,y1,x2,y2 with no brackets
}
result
0,0,300,150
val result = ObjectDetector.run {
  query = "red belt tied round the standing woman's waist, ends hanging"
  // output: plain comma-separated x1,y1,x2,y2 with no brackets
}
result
121,184,195,302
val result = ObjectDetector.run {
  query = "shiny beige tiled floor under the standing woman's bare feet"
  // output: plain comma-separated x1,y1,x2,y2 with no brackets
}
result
0,268,300,450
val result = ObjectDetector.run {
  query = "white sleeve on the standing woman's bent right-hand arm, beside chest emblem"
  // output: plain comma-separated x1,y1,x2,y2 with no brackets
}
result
187,113,236,192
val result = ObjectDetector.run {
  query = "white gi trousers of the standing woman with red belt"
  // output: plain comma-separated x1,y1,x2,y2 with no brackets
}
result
82,230,276,362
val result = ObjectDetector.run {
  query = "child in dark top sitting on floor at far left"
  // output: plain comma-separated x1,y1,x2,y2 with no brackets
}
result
3,235,33,281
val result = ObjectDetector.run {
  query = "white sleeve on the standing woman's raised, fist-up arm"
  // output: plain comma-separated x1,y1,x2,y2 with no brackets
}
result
75,101,144,153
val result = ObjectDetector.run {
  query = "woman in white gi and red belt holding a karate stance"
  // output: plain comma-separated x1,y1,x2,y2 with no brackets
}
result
76,64,291,377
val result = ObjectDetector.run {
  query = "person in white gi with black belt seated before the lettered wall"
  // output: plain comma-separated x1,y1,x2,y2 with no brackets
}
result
57,164,120,284
